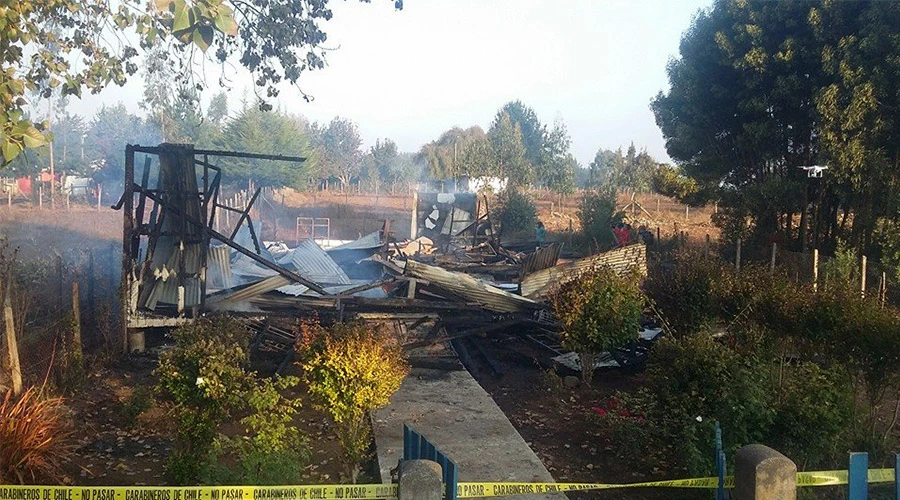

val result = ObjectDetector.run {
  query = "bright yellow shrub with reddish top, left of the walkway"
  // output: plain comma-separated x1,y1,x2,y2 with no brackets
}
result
297,322,409,482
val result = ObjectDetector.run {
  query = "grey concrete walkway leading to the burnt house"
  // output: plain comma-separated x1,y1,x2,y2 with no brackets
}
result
372,368,566,500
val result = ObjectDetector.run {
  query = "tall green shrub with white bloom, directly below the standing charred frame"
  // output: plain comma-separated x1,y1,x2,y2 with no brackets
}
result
156,318,253,484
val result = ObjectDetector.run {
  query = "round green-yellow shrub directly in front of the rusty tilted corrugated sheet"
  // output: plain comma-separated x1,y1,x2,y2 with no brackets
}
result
550,267,644,387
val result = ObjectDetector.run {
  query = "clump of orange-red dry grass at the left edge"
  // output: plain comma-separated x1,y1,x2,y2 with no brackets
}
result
0,387,74,484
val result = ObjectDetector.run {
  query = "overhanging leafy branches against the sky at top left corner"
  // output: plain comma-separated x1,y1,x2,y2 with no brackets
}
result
0,0,403,166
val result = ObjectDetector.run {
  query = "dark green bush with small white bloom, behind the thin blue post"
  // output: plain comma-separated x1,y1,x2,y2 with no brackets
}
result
601,334,772,474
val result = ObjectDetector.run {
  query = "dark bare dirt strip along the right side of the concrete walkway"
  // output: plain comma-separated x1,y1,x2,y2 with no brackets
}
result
464,335,710,500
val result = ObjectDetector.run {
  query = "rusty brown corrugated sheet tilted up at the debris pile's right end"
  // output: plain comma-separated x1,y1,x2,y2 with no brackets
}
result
520,243,647,300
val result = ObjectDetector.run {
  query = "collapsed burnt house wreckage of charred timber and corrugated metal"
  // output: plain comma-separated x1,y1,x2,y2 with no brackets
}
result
113,144,655,374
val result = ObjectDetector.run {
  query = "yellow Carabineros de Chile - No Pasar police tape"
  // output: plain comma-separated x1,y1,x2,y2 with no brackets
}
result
0,469,894,500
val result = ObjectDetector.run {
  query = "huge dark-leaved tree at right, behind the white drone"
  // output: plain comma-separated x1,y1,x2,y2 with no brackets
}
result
652,0,900,254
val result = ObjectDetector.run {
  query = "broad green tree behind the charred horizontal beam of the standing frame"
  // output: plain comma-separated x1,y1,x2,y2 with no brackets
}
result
216,105,318,189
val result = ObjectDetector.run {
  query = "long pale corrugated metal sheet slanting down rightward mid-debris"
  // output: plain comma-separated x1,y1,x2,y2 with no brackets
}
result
404,260,541,313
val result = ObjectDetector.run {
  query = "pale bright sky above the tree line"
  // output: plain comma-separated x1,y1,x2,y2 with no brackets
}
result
69,0,711,166
